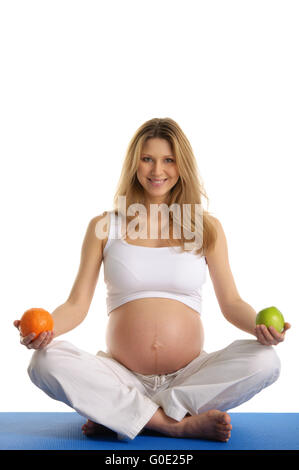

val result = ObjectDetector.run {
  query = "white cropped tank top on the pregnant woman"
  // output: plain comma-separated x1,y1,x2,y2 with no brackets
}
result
103,211,207,315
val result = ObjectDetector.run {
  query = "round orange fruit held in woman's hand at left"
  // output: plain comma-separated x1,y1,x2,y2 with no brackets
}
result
20,308,54,339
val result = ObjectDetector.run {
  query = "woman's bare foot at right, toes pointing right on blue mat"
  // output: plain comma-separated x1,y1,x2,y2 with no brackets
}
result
177,410,232,442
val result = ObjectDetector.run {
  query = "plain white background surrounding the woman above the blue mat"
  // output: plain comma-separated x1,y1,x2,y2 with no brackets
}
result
0,0,299,412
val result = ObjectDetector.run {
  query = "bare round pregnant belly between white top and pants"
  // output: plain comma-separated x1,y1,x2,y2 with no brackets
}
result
106,298,204,375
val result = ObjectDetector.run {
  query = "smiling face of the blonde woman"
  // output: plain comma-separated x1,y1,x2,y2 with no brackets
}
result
137,137,179,205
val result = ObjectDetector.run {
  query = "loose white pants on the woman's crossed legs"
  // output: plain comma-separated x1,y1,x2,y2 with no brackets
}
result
28,339,280,440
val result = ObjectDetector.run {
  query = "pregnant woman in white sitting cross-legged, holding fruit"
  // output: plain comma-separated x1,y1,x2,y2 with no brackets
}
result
14,118,290,441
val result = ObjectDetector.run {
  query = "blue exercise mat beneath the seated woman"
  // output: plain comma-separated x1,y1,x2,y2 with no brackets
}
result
0,412,299,450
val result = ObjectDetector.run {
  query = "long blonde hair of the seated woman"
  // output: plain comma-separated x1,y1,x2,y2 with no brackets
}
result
113,118,217,255
